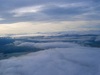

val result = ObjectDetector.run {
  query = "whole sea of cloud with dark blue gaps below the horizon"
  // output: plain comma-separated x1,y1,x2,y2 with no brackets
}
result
0,33,100,75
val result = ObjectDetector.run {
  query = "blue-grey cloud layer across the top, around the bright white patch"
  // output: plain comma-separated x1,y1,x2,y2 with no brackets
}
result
0,0,100,23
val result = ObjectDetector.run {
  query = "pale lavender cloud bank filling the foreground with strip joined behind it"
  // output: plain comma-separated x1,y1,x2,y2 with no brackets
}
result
0,42,100,75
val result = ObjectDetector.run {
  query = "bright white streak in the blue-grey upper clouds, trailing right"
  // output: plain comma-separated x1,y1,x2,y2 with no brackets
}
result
10,2,88,17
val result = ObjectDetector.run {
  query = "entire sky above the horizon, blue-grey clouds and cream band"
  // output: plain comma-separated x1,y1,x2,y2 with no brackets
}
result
0,0,100,34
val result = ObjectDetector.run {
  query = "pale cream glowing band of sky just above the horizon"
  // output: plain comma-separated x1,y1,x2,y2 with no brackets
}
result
0,21,100,34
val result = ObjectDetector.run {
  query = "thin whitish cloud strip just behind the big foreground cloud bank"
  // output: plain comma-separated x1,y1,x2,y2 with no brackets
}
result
14,39,79,49
